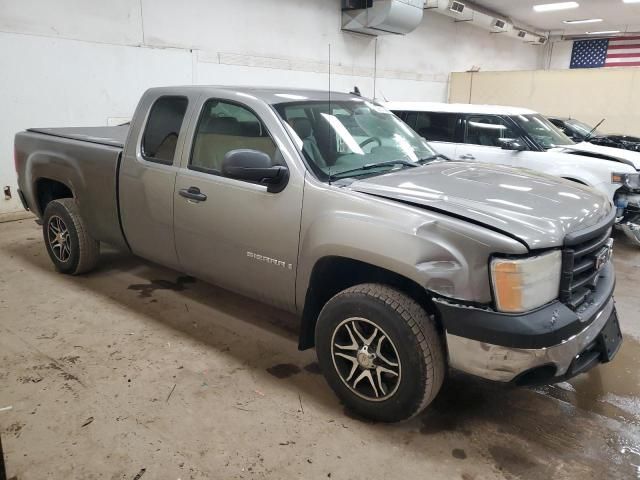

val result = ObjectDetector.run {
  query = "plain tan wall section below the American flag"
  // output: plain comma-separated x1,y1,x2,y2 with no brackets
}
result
449,68,640,135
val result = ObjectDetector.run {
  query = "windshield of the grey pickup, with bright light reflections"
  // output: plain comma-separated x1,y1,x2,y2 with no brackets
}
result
275,99,436,181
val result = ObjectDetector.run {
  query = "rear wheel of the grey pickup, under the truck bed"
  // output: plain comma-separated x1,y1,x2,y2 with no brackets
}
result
42,198,100,275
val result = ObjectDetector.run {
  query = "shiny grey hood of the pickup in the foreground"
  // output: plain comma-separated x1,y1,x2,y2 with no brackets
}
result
349,162,612,249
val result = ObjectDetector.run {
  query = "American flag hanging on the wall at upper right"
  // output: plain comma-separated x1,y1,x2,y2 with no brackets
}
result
571,37,640,68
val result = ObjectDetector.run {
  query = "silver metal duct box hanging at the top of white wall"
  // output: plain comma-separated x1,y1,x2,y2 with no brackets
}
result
342,0,424,36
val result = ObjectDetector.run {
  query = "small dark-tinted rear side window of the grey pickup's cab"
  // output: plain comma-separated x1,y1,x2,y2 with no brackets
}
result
142,97,188,165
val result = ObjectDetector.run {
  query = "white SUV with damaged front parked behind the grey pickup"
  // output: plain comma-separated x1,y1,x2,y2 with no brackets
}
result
385,102,640,246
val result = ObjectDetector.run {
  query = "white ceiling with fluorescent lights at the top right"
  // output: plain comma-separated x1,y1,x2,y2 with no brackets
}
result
470,0,640,35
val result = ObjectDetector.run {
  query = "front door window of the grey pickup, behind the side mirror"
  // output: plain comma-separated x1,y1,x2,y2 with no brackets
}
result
189,99,281,175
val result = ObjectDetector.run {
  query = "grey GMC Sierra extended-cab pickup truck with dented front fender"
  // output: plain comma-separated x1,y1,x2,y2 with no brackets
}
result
15,86,622,421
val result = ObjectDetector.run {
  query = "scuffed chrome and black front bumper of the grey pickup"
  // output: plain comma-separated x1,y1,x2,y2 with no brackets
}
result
437,264,622,384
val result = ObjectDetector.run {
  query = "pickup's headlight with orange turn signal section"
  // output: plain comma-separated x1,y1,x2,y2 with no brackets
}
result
491,250,562,313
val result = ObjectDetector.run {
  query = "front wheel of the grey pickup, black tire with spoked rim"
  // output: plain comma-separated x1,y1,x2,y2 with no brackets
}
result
315,283,445,422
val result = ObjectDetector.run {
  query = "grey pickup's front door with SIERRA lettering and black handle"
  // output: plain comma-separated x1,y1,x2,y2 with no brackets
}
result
174,92,304,310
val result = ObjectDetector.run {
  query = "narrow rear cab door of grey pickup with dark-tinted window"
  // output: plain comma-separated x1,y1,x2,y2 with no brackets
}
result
118,89,198,268
